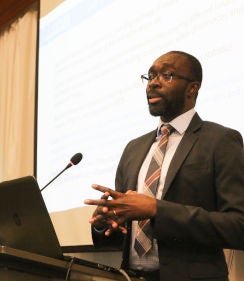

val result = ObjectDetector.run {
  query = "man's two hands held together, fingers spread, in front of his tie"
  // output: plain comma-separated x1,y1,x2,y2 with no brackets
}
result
84,184,156,235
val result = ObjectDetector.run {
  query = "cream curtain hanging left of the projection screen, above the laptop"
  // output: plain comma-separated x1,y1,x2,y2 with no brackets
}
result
0,3,38,181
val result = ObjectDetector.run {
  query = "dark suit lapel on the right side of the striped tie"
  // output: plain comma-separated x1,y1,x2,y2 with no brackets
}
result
161,113,202,199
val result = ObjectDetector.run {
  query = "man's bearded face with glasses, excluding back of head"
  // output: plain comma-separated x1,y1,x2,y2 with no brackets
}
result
146,53,195,121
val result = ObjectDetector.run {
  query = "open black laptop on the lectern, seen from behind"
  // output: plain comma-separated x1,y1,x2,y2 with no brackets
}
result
0,176,121,272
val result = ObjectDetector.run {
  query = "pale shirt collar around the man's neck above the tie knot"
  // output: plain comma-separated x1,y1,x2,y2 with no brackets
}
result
157,108,196,138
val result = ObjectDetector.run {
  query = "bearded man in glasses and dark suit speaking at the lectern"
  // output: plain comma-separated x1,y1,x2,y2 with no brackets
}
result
85,51,244,281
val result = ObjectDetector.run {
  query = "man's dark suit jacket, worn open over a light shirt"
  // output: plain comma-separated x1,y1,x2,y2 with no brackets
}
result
93,114,244,281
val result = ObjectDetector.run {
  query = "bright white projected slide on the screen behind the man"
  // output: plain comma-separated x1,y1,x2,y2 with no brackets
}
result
37,0,244,211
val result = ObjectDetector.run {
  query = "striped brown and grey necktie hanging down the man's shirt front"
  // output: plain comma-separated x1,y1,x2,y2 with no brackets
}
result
134,125,174,257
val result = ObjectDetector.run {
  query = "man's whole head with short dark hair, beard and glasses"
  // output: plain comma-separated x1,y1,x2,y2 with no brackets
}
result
146,51,202,122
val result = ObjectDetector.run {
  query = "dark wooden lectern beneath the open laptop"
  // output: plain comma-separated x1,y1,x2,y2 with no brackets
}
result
0,246,142,281
